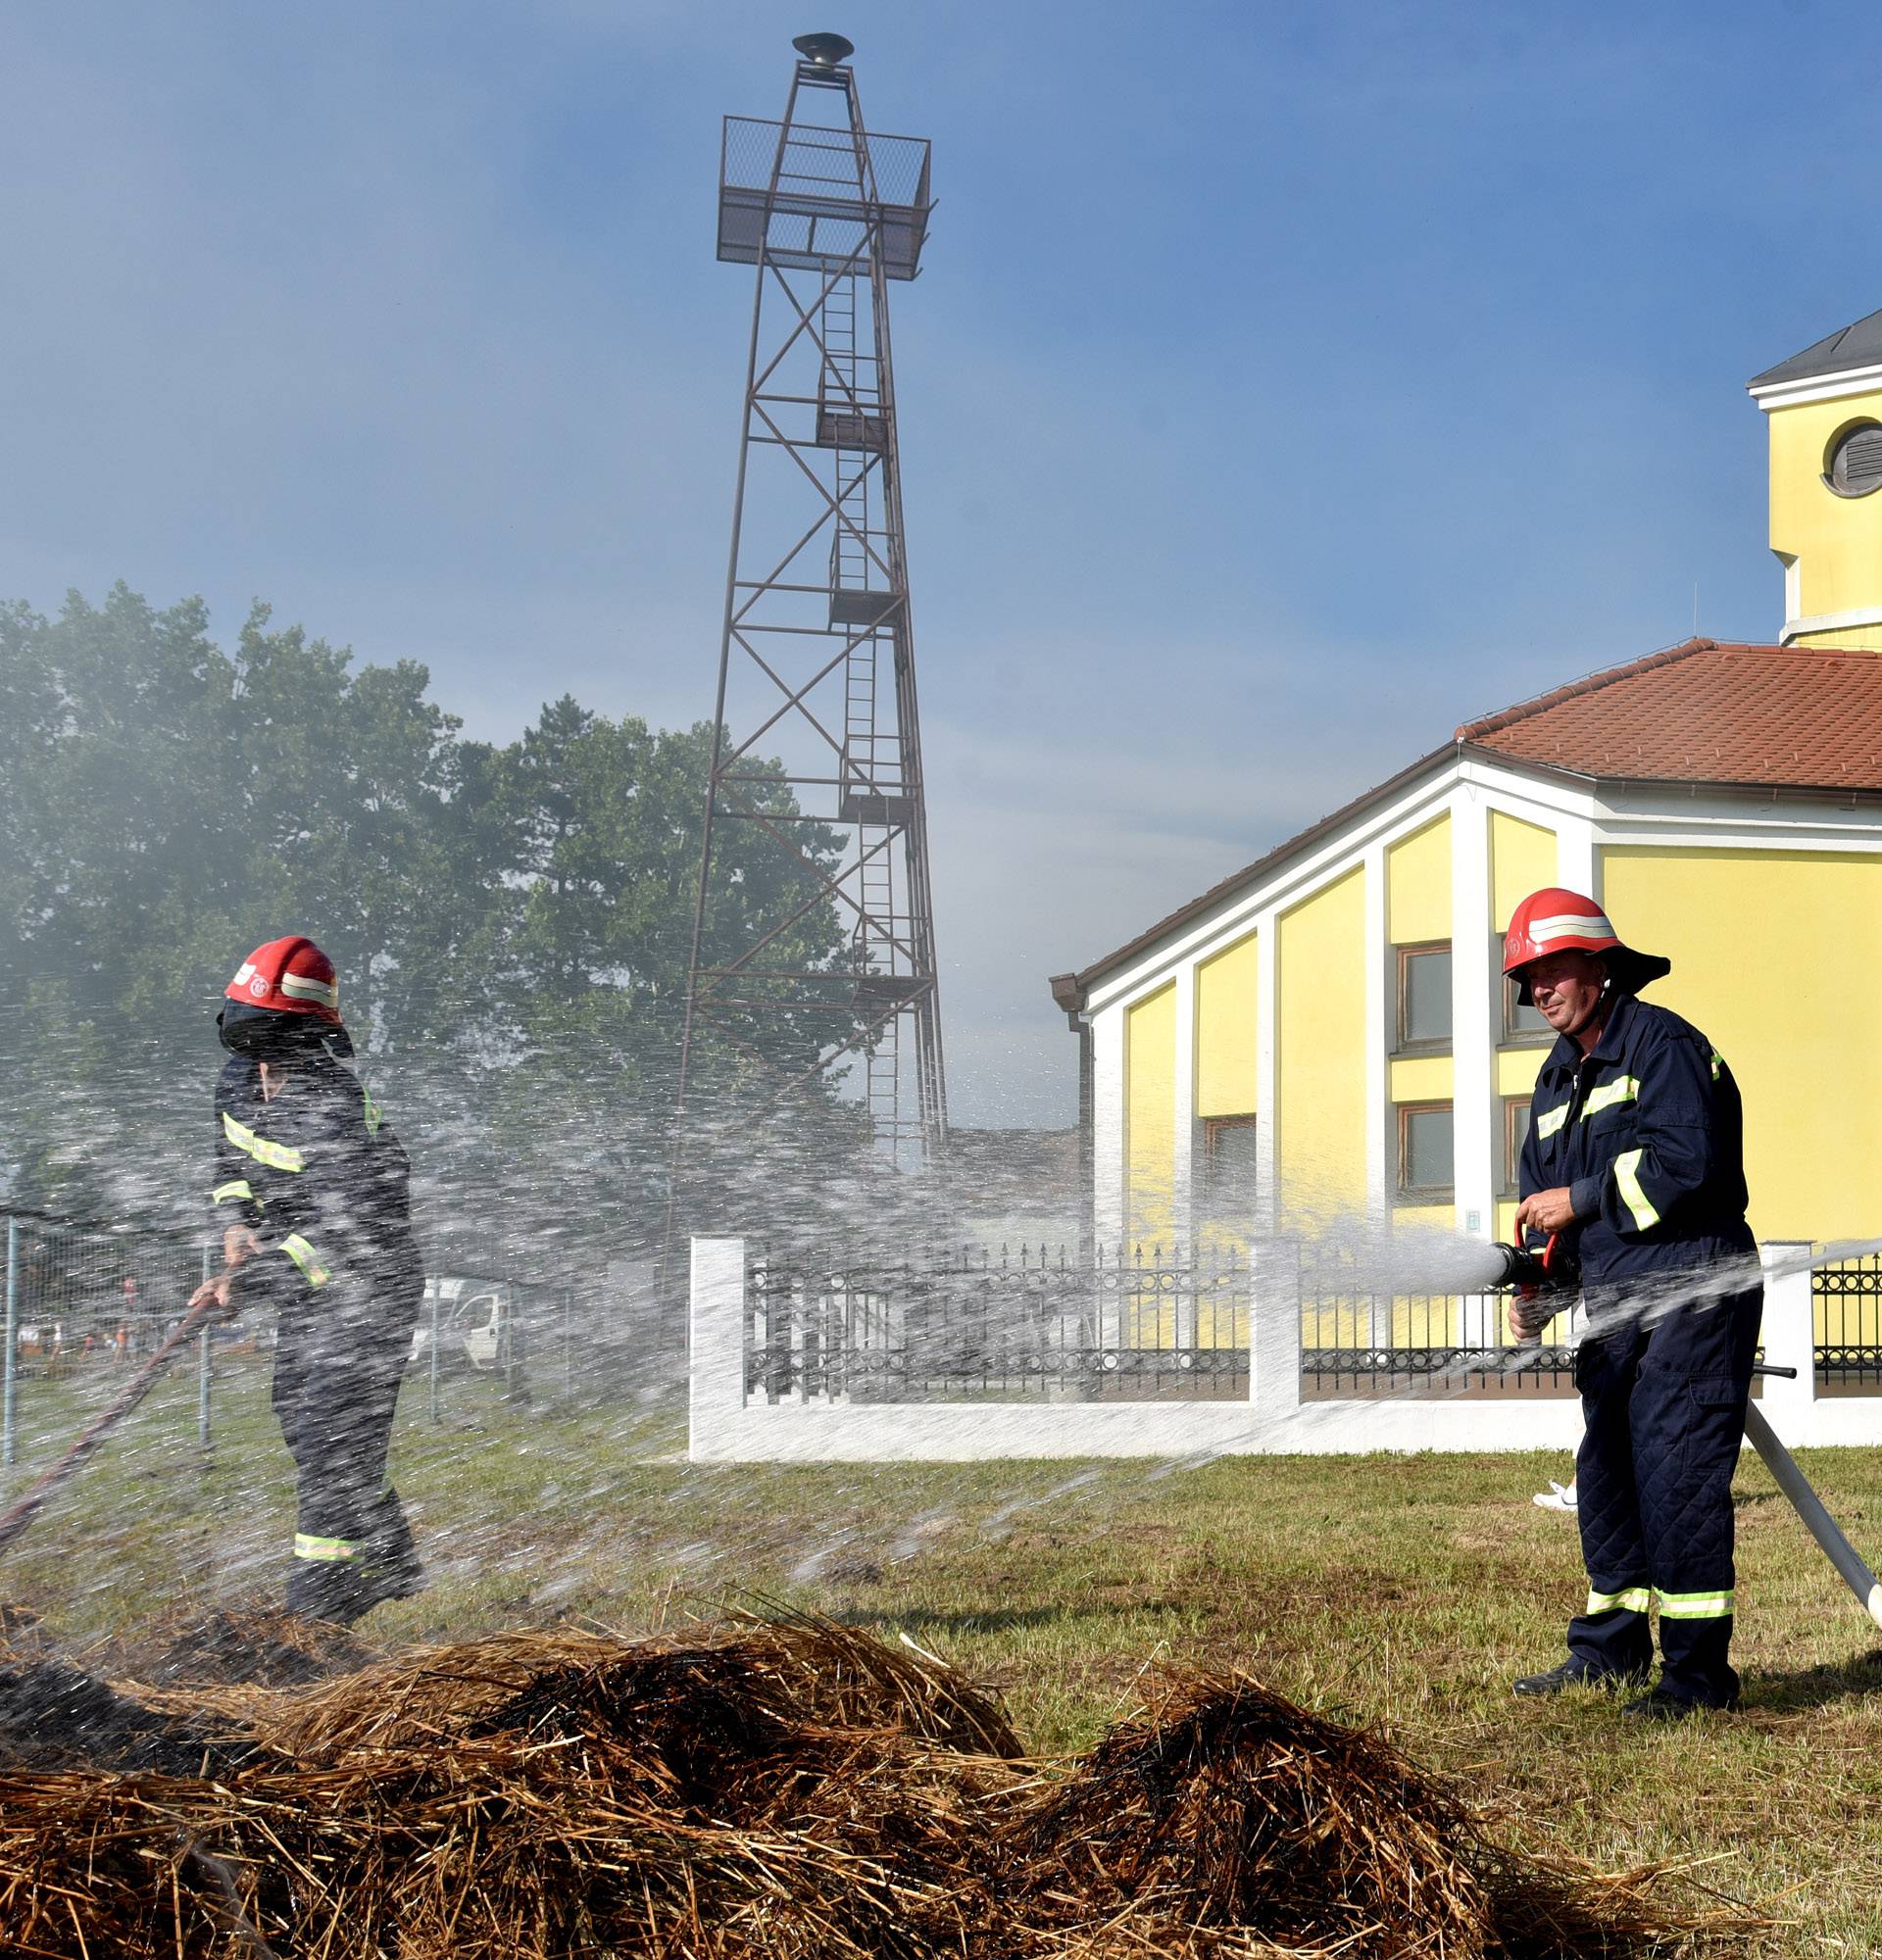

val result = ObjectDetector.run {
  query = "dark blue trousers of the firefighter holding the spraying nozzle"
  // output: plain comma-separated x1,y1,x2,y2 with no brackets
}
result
1568,1286,1764,1707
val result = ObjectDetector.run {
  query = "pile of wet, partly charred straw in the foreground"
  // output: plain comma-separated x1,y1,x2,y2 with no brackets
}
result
0,1621,1733,1960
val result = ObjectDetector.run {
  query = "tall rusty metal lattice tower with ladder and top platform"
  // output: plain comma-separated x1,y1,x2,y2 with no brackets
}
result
674,35,947,1170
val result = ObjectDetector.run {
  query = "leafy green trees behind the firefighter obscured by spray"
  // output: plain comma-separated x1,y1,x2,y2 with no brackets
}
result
0,584,847,1247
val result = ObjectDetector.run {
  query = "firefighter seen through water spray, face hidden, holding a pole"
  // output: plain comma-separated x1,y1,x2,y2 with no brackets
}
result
192,937,425,1625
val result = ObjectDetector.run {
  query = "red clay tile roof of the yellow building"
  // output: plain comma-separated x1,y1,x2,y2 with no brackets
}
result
1457,639,1882,790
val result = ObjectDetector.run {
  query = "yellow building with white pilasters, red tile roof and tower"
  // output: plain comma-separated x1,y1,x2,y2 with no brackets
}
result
1051,314,1882,1245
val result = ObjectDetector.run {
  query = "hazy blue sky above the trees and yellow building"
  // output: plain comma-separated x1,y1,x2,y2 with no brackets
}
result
0,0,1882,1123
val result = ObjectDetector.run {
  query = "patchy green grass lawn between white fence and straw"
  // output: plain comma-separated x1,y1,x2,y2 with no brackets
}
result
0,1368,1882,1954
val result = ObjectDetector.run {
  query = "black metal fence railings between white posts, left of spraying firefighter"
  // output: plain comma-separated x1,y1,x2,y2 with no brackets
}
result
745,1245,1574,1401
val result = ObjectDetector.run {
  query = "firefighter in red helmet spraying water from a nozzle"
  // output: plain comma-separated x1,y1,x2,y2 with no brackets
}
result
1504,888,1764,1721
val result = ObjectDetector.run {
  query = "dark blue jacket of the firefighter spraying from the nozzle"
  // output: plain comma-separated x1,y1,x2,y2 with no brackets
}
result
1519,994,1757,1288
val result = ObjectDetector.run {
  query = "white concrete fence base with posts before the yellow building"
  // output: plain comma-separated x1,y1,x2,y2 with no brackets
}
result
686,1239,1882,1462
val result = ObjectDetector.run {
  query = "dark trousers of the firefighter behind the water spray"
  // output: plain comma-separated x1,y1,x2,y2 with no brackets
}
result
272,1278,423,1623
